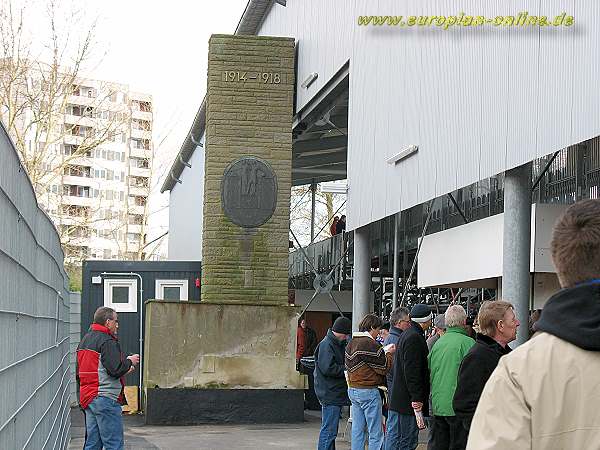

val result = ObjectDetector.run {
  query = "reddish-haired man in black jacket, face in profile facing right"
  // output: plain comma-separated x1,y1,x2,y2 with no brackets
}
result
452,300,519,438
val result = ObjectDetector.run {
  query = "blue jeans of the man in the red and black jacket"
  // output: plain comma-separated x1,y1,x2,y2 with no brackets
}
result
84,397,125,450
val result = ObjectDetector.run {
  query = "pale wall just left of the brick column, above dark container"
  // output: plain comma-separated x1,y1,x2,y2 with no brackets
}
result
169,136,204,261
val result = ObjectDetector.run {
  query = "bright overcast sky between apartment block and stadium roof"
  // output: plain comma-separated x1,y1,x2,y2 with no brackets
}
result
73,0,247,254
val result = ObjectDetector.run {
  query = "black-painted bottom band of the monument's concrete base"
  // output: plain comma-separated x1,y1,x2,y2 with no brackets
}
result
146,388,304,425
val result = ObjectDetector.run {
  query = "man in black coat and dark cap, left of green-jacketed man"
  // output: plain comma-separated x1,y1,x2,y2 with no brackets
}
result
390,304,433,450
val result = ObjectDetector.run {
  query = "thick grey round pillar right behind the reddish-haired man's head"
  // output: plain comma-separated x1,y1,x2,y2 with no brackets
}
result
502,163,531,346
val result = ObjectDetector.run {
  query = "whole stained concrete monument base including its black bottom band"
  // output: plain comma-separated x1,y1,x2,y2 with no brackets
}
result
144,300,306,424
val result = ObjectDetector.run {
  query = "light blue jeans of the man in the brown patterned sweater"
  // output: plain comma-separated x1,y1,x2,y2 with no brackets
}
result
348,388,383,450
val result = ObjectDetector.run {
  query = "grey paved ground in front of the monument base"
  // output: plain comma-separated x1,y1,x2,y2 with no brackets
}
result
69,409,425,450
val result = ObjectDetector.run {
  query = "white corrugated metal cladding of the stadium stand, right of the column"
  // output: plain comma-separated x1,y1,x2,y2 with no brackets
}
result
163,0,600,229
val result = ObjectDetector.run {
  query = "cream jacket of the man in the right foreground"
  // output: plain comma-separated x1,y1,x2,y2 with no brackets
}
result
467,310,600,450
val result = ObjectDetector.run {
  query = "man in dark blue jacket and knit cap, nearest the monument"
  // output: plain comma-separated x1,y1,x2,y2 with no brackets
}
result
314,317,352,450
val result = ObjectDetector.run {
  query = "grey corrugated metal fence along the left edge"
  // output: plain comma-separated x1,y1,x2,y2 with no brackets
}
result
0,121,70,450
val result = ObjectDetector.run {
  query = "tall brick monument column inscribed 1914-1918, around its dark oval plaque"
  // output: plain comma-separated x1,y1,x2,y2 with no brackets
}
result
202,35,294,304
